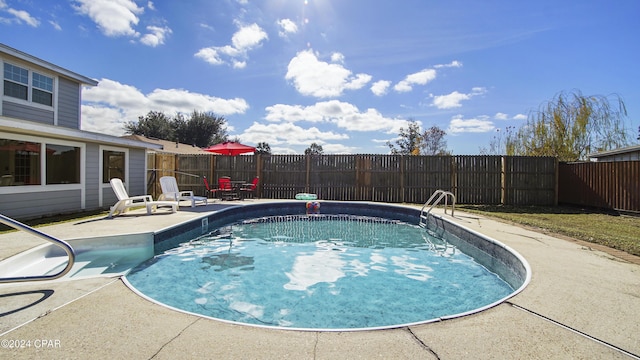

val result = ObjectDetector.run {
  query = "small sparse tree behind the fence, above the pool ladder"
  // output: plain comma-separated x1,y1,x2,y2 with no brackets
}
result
387,120,449,155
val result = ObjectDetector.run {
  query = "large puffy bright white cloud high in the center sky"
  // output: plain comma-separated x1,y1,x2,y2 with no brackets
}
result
285,50,371,98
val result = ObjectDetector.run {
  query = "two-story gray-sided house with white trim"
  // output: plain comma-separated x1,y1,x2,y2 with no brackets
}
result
0,43,160,219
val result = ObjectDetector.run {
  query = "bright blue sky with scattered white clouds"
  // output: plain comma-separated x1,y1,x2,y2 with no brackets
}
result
0,0,640,155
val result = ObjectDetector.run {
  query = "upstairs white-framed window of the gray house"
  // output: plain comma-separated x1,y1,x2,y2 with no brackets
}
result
4,63,53,106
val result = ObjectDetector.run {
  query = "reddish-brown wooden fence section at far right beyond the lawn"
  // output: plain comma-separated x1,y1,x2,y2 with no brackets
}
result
558,161,640,211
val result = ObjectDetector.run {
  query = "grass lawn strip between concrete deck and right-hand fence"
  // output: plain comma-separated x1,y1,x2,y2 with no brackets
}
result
456,205,640,256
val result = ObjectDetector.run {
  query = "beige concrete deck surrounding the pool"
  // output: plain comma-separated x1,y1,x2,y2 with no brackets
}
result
0,200,640,359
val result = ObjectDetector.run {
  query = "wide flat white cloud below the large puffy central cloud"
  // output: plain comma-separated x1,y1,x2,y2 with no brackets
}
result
265,100,407,133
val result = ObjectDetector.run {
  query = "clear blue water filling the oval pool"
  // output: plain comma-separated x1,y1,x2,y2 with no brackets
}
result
127,215,514,329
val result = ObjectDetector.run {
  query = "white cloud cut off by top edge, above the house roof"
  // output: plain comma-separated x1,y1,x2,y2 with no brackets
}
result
72,0,144,37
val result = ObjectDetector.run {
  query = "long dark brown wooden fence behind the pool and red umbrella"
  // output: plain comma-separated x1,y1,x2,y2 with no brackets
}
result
148,154,557,205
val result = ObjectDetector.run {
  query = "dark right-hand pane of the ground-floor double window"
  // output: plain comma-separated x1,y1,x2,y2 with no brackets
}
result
45,144,80,185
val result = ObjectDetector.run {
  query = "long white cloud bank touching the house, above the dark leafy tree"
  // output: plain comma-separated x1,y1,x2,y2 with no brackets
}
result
82,79,249,135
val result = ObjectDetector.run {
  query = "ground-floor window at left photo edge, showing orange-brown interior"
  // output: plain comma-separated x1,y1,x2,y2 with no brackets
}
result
0,139,41,186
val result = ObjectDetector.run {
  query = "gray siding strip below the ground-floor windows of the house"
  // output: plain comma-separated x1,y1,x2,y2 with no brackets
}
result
0,190,80,219
